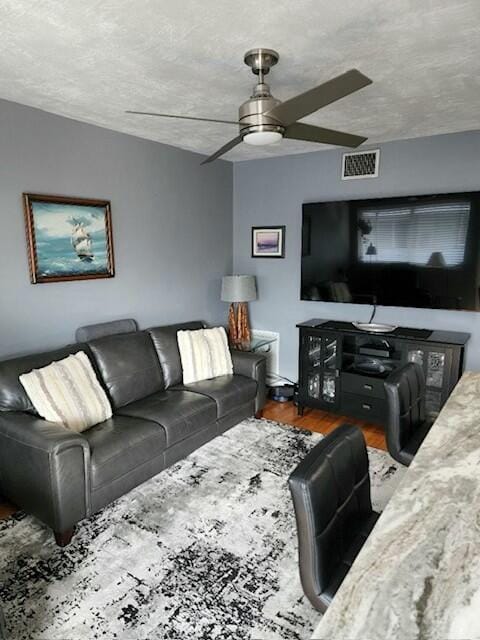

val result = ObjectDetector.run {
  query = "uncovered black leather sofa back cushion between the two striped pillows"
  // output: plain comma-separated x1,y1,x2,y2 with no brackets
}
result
88,331,165,408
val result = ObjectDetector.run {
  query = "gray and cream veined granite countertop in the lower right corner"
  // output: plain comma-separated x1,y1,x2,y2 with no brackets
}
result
313,372,480,640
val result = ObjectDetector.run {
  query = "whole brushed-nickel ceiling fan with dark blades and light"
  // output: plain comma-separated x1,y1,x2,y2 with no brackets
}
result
126,48,372,164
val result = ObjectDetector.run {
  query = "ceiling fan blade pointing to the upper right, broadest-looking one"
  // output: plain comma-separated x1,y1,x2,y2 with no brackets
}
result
264,69,372,126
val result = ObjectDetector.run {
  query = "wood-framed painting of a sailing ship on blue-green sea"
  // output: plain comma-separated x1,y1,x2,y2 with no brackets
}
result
23,193,114,284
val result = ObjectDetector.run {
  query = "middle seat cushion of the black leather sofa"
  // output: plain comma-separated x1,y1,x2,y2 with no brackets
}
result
119,390,217,447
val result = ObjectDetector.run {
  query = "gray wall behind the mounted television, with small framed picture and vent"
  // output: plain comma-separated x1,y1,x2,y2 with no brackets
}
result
234,132,480,379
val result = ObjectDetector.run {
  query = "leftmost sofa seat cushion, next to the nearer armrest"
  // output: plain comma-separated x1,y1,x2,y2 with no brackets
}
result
82,415,167,490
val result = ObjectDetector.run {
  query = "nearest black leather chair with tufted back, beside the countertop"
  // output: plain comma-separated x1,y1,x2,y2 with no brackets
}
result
288,424,379,613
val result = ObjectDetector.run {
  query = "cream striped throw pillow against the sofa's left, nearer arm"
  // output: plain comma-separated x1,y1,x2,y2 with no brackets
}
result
20,351,112,433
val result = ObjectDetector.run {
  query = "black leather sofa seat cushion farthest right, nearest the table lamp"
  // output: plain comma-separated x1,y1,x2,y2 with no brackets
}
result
175,375,257,418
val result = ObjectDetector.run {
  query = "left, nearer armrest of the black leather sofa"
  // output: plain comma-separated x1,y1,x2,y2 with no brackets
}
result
0,412,90,532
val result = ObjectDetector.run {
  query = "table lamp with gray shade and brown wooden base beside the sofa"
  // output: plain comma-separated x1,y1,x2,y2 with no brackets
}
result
221,275,257,346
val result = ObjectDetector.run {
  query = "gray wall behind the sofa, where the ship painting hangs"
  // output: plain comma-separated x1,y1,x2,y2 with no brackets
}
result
0,101,232,357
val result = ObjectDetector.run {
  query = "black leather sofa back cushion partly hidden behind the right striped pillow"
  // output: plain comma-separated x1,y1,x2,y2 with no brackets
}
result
148,320,205,389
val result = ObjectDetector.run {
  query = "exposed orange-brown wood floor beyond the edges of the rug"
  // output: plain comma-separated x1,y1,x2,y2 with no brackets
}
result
0,400,387,520
